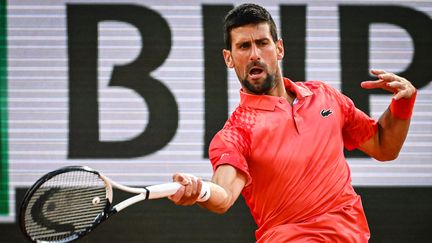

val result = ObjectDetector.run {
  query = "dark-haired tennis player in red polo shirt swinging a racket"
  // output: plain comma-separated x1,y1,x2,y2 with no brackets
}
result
170,4,416,242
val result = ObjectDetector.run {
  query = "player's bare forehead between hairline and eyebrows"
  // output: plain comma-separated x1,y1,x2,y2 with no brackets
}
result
231,22,271,42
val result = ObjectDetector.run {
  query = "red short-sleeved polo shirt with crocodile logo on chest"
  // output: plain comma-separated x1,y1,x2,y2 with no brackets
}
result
209,79,377,242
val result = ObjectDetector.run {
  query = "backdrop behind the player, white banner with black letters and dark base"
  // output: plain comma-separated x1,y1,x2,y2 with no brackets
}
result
0,0,432,242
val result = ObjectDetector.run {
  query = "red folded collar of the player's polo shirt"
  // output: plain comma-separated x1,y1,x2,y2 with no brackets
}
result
240,78,313,111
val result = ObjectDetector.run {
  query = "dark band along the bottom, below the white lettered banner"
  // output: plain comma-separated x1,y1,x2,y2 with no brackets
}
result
5,187,432,243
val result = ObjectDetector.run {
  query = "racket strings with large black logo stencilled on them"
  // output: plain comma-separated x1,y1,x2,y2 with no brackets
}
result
24,171,109,242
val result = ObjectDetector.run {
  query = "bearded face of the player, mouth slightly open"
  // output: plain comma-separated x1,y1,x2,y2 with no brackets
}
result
224,23,284,94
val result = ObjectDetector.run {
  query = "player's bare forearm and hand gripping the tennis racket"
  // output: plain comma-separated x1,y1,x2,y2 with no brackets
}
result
169,164,246,214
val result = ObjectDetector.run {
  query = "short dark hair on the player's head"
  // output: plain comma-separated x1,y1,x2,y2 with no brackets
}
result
224,3,278,50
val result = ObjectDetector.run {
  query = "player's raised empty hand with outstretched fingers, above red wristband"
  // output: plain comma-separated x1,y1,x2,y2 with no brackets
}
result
361,69,416,100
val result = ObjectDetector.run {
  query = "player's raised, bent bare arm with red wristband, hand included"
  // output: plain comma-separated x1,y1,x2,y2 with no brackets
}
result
359,70,417,161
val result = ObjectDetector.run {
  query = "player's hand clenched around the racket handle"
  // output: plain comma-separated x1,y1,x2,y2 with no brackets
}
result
168,173,202,206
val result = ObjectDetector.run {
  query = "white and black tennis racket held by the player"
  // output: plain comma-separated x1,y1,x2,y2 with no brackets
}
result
19,166,210,243
